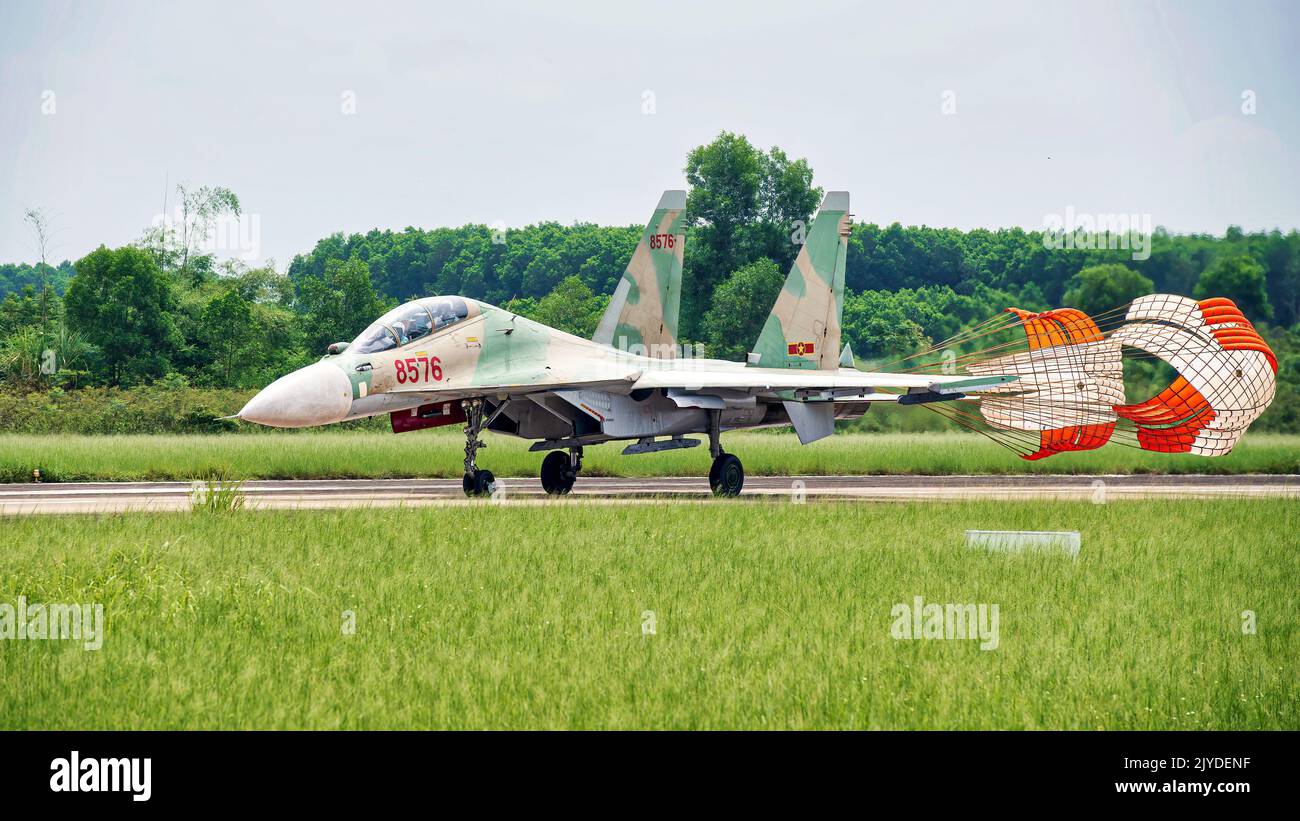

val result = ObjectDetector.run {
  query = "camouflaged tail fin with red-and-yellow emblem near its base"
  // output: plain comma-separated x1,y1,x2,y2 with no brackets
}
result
750,191,850,370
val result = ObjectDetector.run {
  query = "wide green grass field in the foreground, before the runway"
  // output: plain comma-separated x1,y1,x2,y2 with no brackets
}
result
0,500,1300,729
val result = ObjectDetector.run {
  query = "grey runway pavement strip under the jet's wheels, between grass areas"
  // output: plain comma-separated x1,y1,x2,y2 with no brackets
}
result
0,475,1300,514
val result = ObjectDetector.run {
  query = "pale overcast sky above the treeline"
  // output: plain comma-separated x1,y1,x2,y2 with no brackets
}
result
0,0,1300,270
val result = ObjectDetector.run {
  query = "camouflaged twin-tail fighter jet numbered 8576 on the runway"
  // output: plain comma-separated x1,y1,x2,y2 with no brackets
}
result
235,191,1017,496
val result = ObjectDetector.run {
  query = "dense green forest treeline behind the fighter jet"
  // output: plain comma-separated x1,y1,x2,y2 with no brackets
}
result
0,133,1300,431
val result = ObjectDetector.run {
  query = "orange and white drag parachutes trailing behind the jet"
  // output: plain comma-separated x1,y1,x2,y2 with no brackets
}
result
899,294,1278,459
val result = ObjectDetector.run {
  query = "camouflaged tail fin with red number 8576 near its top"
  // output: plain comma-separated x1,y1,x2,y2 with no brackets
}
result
592,191,686,359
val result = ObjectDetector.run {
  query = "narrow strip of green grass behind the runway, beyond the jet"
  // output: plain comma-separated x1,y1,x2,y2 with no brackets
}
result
0,427,1300,482
